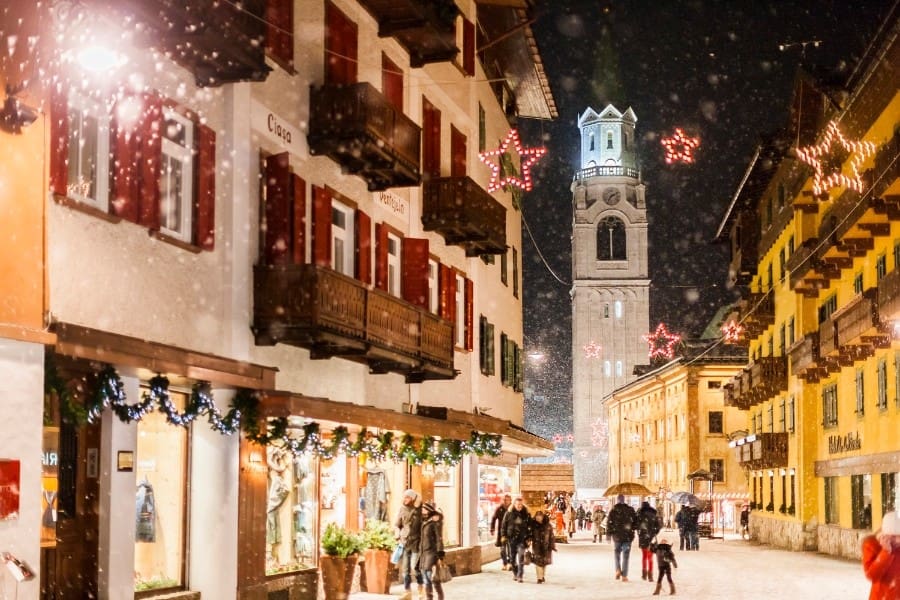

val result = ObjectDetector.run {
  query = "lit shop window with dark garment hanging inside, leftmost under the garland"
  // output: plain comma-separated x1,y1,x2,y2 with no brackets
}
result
134,391,188,591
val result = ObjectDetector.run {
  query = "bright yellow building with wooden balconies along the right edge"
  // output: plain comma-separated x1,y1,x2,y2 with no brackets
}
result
719,23,900,557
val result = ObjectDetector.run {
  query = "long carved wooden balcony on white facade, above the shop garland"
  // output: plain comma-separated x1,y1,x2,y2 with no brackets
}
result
253,264,456,383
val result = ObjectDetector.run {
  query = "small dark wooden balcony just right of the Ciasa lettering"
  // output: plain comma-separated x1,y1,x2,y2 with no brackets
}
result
307,82,422,191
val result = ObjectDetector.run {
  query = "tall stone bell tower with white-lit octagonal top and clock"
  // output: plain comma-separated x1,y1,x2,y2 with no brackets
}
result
571,104,650,492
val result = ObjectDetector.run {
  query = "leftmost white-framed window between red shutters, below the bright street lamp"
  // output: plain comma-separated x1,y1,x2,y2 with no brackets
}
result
66,94,110,212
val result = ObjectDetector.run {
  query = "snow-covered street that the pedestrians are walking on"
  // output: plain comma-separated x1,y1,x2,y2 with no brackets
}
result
400,531,869,600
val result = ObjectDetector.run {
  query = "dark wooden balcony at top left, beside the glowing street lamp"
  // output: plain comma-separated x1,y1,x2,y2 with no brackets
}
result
103,0,271,86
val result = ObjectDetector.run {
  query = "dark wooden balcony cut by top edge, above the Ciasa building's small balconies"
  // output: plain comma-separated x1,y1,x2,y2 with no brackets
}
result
359,0,459,68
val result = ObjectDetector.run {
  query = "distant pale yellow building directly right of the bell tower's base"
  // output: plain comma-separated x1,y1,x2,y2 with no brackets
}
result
604,345,747,528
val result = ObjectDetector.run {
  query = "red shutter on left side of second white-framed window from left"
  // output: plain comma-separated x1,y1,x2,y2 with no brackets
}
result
135,94,164,230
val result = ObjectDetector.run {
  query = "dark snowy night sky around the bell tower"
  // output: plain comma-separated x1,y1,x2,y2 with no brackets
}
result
519,0,895,448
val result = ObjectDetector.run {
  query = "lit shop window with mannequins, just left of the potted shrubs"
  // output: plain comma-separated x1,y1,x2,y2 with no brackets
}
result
266,446,324,575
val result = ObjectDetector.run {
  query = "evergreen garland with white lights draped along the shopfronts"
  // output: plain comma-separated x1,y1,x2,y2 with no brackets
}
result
44,360,502,465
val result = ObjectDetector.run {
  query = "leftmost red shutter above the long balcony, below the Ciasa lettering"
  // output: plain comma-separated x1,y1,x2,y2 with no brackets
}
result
263,152,293,265
